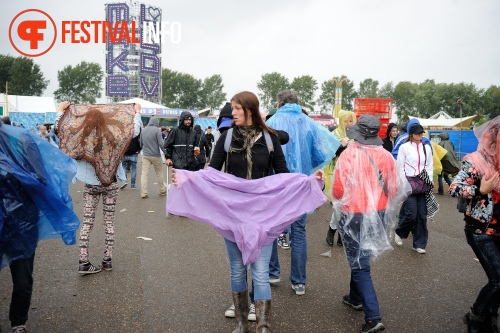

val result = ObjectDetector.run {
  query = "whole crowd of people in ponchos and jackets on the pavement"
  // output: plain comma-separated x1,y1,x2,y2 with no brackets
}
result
0,90,500,333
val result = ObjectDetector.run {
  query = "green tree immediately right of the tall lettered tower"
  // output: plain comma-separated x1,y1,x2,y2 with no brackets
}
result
161,68,202,110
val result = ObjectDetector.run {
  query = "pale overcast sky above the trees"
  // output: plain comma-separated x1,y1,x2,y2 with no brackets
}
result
0,0,500,109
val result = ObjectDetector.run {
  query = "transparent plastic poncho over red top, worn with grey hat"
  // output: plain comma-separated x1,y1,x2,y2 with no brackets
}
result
332,142,411,268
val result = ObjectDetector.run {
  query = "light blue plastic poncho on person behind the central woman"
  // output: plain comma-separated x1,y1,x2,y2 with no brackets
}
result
266,104,340,175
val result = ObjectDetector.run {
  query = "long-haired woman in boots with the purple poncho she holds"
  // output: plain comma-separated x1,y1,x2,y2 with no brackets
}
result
167,91,326,333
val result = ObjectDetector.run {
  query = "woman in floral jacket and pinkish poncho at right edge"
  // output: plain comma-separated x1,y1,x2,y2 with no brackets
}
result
449,116,500,333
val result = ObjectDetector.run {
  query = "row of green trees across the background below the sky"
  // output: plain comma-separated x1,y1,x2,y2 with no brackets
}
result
0,54,500,120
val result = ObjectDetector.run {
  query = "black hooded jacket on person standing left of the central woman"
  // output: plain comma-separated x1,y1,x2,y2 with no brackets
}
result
163,111,196,170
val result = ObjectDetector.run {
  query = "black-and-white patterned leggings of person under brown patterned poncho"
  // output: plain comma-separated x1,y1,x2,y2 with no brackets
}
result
79,182,118,262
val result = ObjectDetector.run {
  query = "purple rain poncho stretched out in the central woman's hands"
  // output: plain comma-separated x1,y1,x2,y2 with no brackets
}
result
167,167,326,265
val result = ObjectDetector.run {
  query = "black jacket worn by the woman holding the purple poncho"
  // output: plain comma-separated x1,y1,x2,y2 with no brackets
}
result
210,127,290,179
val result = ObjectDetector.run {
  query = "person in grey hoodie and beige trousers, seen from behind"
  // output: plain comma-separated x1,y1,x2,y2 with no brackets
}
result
139,116,167,199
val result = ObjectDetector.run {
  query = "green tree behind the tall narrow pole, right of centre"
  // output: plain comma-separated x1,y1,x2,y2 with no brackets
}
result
318,75,357,114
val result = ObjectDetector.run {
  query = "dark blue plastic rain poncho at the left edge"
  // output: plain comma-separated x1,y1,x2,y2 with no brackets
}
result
0,123,80,268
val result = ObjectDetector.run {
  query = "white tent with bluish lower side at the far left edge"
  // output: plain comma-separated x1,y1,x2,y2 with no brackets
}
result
0,94,57,129
